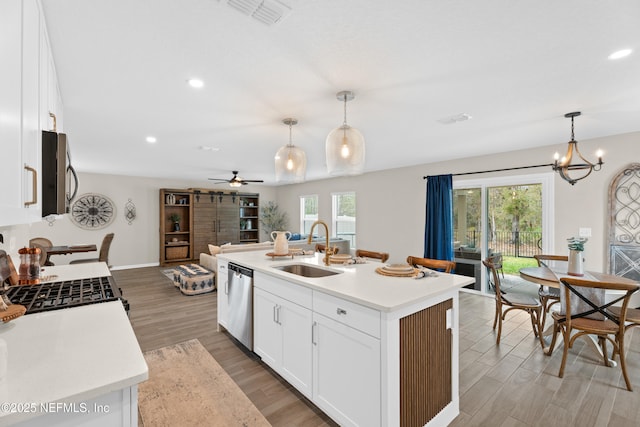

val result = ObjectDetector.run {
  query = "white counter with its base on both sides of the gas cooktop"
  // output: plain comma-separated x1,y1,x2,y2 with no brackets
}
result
0,263,148,426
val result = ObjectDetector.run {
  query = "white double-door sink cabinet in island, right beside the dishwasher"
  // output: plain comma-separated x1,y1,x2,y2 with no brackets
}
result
253,272,313,399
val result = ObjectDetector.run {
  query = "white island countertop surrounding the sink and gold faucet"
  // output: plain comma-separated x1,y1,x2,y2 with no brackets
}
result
217,251,475,312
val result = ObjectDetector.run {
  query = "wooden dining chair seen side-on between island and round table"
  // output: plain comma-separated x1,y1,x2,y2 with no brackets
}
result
482,258,544,349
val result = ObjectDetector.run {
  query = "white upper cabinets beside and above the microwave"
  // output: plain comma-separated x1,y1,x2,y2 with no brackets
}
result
0,0,62,227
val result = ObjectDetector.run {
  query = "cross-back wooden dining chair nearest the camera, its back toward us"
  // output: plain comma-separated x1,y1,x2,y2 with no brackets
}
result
546,277,639,391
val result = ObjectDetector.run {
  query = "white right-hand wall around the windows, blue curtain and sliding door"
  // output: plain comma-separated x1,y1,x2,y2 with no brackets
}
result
277,132,640,271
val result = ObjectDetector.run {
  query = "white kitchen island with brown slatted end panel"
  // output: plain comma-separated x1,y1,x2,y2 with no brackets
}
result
218,251,473,426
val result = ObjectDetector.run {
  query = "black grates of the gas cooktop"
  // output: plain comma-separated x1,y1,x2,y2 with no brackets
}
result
7,276,129,314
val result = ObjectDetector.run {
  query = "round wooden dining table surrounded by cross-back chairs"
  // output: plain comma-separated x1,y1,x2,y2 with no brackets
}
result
520,265,637,366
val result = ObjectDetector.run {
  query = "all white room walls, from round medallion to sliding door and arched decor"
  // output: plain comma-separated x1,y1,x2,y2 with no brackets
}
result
0,132,640,271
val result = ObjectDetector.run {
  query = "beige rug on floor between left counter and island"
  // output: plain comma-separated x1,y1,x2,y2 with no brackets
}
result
138,339,271,427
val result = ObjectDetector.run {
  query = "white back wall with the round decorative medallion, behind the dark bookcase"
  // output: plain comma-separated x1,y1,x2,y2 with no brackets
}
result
0,173,275,268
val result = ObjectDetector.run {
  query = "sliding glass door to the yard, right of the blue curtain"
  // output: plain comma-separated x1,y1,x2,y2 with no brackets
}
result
453,174,553,293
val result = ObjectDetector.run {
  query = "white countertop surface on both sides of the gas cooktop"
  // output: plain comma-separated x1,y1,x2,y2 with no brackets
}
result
0,263,148,425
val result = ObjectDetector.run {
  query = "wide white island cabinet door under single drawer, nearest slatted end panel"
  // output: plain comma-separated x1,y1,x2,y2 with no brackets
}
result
312,313,381,427
